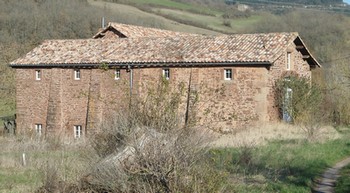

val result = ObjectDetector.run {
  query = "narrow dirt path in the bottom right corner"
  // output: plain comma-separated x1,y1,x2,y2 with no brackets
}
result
312,157,350,193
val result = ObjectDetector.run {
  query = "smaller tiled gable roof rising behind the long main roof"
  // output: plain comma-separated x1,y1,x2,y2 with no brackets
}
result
93,22,194,39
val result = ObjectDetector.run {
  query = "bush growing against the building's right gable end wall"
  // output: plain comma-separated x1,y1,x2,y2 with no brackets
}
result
276,75,326,140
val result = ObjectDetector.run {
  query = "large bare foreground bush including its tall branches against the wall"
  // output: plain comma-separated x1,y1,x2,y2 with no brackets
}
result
81,79,225,192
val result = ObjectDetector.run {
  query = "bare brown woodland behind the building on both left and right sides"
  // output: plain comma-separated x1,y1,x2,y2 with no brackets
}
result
0,0,350,123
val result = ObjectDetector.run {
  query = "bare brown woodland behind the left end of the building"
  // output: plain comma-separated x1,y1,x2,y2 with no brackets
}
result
0,0,167,116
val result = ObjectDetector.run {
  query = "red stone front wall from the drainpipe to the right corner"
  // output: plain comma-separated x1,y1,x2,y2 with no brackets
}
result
131,67,268,132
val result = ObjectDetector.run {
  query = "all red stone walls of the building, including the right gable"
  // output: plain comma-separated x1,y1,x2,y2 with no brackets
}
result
16,45,311,136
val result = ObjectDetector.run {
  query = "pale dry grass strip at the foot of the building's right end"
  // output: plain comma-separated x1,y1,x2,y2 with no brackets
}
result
212,123,340,147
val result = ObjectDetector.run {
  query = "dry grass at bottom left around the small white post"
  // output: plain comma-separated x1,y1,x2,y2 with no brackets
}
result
0,137,88,192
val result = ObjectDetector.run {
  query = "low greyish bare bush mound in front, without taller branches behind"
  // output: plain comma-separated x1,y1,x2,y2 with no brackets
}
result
83,123,222,192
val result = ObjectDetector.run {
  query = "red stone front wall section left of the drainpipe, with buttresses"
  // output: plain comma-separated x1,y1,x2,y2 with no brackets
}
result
16,68,129,136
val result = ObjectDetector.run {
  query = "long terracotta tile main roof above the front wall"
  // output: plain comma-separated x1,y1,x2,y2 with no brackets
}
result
10,33,318,67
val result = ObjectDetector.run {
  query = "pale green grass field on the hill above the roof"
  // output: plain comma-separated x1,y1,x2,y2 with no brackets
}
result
89,0,265,34
